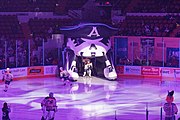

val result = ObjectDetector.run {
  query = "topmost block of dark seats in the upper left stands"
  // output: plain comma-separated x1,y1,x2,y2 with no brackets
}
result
0,0,87,14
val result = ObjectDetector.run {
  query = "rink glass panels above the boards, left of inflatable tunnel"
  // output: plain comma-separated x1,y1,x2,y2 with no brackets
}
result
0,37,62,69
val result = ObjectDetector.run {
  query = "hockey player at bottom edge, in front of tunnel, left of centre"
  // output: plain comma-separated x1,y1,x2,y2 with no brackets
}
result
41,92,57,120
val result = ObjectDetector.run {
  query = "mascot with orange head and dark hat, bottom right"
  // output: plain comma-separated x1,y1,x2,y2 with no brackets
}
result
163,91,178,120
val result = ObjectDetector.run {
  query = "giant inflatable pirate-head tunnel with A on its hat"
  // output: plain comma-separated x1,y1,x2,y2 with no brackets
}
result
60,23,117,80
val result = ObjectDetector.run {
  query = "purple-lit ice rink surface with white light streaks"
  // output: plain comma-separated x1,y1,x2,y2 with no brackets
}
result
0,77,180,120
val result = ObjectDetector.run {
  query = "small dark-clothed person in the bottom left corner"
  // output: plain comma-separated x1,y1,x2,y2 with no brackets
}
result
2,102,11,120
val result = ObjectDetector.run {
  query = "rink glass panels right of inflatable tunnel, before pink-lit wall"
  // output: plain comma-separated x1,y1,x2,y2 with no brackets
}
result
113,36,180,67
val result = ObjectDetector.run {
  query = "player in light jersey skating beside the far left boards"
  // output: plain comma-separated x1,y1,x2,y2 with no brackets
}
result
2,68,13,92
